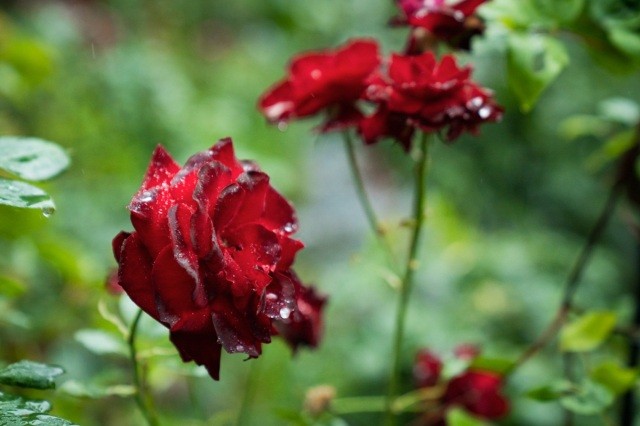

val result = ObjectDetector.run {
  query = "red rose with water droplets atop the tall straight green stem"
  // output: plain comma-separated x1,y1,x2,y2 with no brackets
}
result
358,52,502,150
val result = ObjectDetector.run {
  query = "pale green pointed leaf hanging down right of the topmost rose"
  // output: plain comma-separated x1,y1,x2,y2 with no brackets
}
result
507,34,569,111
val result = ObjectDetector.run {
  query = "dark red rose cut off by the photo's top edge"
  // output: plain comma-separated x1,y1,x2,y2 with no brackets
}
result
392,0,486,50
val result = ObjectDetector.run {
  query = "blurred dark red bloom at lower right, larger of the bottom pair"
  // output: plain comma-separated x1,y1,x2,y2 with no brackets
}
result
443,371,509,420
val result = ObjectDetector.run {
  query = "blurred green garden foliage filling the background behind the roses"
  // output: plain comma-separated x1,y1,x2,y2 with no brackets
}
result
0,0,640,425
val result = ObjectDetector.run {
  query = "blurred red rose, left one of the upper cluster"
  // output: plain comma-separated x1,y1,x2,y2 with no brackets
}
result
258,39,380,131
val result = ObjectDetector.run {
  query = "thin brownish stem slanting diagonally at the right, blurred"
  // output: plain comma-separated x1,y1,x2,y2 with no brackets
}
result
505,181,621,376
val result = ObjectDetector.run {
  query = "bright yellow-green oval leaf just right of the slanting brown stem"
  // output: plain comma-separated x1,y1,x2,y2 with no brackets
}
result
560,311,616,352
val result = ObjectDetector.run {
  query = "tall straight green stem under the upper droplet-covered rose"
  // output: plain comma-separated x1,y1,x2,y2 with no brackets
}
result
385,134,429,426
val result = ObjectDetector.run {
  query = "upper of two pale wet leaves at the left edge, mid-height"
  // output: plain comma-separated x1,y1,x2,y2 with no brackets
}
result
0,137,69,181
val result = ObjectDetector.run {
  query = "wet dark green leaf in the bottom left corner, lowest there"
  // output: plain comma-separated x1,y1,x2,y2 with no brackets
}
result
0,392,72,426
